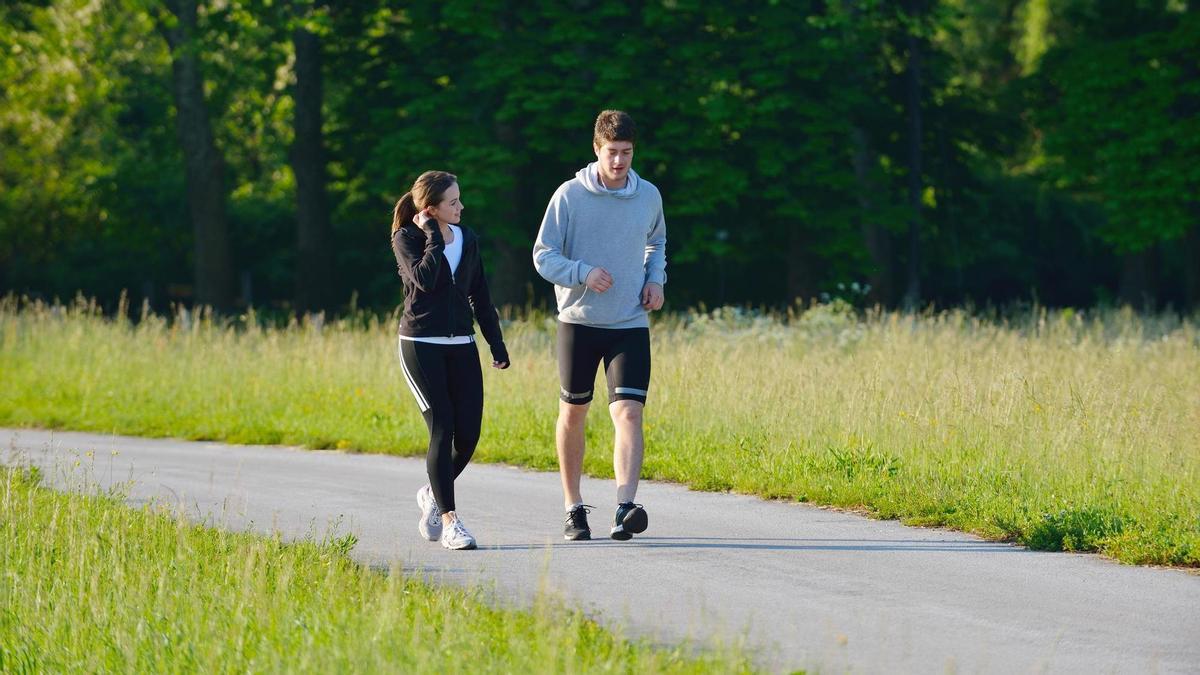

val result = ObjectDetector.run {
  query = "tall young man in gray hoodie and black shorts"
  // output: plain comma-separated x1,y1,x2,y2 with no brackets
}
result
533,110,667,540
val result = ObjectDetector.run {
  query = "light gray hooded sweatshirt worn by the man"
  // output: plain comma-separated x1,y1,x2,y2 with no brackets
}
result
533,162,667,328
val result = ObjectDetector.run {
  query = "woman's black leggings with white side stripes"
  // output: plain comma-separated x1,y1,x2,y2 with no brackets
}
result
400,340,484,512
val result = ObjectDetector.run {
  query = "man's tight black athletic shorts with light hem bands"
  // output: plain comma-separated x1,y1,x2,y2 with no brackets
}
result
558,321,650,405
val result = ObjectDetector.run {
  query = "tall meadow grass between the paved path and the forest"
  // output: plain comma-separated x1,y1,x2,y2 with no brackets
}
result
0,299,1200,567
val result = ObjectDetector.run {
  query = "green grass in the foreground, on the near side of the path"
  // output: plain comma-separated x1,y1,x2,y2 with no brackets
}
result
0,467,749,674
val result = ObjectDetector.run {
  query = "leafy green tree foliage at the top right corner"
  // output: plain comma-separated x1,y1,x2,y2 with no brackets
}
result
1036,0,1200,307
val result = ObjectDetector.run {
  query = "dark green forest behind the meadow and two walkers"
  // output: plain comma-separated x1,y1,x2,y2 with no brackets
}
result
0,0,1200,311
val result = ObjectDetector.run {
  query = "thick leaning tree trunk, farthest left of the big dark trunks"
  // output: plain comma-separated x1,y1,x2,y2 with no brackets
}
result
158,0,234,310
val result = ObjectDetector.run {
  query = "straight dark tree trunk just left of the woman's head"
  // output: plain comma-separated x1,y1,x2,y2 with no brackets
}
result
290,4,334,312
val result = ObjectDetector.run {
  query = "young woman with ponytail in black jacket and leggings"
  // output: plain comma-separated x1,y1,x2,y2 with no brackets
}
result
391,171,509,550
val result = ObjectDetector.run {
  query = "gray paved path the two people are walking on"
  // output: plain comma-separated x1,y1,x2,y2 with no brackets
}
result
0,430,1200,673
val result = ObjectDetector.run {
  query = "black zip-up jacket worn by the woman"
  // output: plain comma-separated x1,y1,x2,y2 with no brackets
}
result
391,223,509,363
